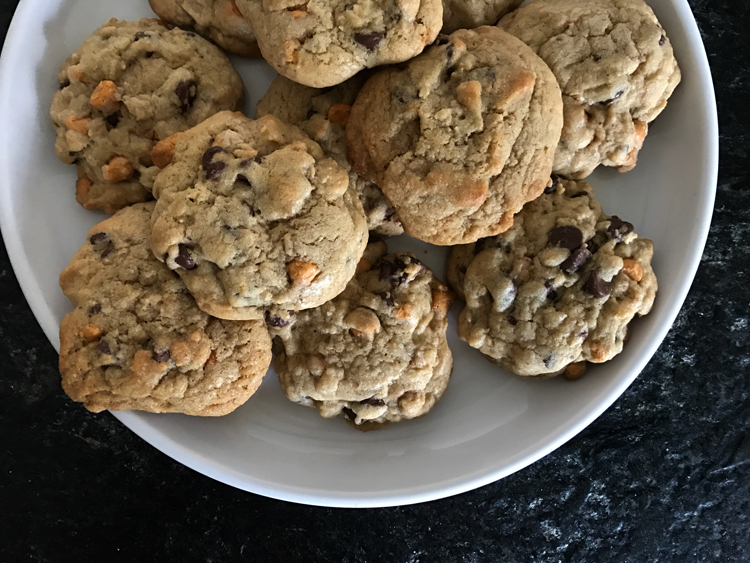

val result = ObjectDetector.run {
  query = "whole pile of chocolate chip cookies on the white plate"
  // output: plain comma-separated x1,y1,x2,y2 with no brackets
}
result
51,0,680,429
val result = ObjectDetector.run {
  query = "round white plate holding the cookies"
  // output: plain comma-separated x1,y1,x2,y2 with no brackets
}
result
0,0,718,507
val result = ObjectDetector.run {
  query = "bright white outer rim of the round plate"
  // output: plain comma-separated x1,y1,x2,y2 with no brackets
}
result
0,0,719,508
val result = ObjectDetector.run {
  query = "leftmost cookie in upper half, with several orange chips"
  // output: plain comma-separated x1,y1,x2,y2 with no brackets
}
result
50,19,244,214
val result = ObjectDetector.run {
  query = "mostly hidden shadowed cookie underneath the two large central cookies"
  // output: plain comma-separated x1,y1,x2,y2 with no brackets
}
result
256,73,404,236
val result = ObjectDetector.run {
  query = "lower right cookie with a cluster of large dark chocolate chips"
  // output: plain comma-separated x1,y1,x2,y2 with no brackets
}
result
449,177,657,376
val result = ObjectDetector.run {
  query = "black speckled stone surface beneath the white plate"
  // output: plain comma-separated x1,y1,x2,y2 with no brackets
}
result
0,0,750,563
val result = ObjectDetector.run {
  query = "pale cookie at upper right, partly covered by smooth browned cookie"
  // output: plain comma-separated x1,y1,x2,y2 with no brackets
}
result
498,0,680,179
